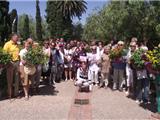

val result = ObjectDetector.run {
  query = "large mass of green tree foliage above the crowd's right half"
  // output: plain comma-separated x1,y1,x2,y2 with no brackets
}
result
83,0,160,47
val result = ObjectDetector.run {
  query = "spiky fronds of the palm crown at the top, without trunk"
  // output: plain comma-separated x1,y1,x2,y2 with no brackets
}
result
57,0,87,19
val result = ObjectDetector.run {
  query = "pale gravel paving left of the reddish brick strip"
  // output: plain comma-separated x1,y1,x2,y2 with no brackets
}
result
0,82,75,120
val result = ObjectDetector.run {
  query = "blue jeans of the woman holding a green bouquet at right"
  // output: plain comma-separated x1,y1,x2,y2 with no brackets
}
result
136,78,149,102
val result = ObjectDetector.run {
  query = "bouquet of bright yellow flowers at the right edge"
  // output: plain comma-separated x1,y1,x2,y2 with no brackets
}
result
147,46,160,71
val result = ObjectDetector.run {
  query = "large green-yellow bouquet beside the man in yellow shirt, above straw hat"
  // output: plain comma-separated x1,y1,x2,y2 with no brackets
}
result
23,46,48,66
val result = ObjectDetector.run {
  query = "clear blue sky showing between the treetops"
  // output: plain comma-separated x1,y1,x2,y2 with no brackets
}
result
9,0,108,24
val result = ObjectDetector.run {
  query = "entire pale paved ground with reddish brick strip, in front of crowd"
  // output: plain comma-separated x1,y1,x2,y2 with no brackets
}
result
0,81,155,120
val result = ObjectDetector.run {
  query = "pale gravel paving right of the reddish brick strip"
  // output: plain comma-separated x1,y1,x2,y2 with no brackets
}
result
92,87,151,120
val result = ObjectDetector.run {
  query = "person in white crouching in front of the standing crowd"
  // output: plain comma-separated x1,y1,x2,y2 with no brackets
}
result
75,62,92,91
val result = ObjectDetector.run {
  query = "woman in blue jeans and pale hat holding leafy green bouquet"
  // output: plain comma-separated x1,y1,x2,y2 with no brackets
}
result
131,46,149,103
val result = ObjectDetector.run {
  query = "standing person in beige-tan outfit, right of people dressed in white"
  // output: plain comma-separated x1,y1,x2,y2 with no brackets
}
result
100,46,110,87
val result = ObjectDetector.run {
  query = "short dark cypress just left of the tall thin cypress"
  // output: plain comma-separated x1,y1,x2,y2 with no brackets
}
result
23,15,30,40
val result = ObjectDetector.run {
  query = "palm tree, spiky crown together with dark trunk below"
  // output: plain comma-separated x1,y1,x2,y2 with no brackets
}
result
57,0,87,39
